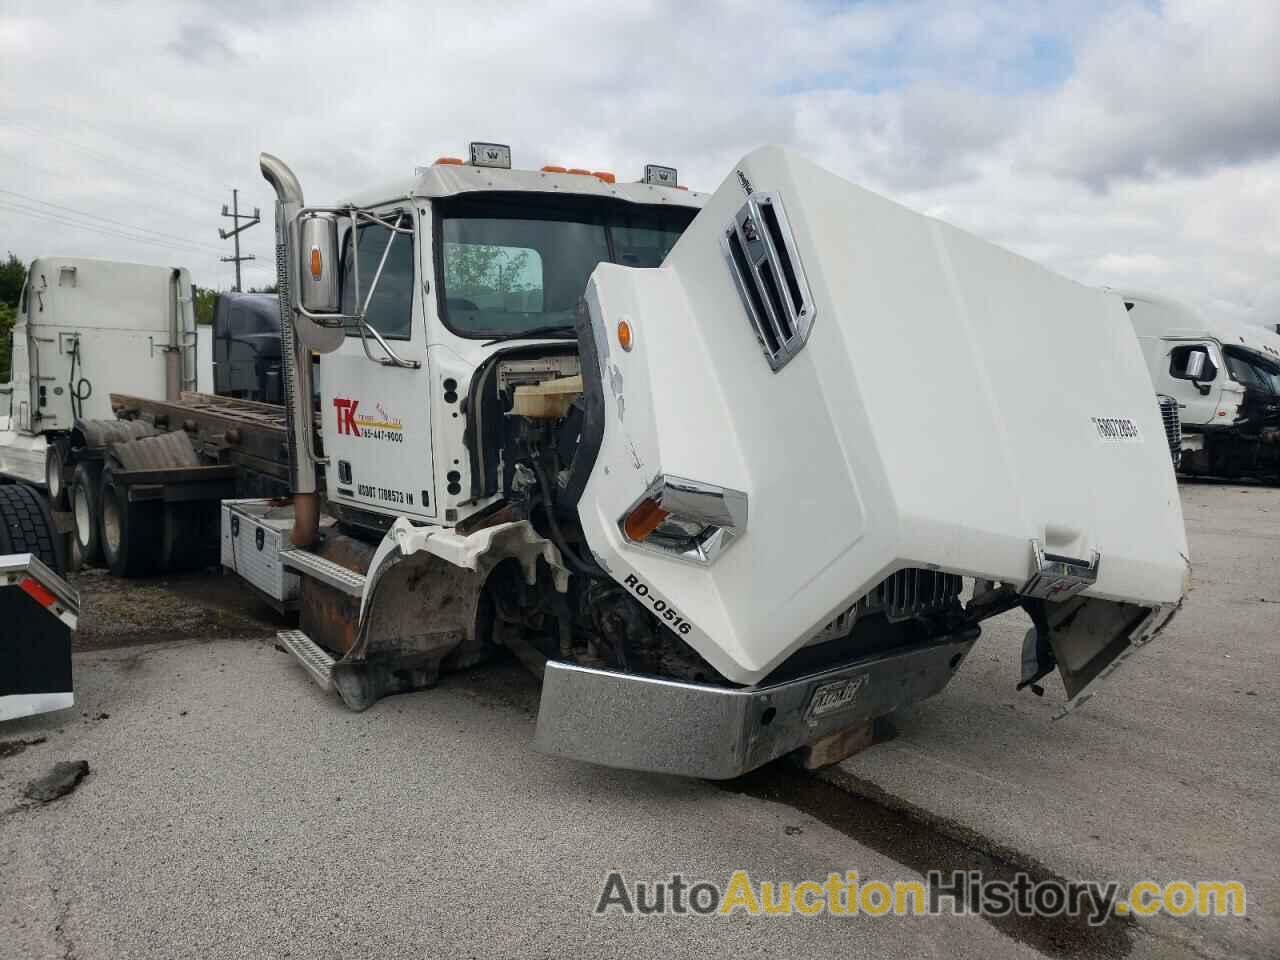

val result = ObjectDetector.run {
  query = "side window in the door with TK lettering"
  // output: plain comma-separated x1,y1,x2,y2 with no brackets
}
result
342,214,413,340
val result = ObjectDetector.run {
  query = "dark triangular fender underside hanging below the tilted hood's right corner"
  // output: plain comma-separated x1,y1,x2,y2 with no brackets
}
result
1039,596,1174,712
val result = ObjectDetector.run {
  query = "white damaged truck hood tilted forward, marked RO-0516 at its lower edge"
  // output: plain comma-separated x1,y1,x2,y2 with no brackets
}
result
579,147,1188,684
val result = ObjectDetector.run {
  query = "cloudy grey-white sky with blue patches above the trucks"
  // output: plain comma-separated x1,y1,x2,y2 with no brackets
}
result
0,0,1280,324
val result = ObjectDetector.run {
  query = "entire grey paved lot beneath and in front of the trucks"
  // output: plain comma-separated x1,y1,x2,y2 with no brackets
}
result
0,485,1280,960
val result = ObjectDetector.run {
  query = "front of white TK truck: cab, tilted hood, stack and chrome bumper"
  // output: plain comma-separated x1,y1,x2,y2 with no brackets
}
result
223,143,1188,778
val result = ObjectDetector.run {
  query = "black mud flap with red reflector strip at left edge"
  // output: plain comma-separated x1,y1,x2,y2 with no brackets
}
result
0,553,79,721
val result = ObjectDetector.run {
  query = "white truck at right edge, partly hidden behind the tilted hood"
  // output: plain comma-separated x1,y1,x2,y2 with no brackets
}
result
1111,291,1280,483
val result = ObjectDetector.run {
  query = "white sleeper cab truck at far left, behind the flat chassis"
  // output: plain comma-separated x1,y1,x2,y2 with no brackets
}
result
0,257,202,561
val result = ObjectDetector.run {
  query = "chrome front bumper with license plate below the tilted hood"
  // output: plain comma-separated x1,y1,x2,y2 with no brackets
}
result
534,637,977,780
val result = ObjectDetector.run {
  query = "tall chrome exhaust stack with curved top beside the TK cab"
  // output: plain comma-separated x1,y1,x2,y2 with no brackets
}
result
259,154,320,547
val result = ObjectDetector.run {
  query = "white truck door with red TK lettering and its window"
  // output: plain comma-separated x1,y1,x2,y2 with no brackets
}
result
321,207,435,518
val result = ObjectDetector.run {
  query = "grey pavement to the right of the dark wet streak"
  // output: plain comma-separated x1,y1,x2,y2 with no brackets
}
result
828,484,1280,957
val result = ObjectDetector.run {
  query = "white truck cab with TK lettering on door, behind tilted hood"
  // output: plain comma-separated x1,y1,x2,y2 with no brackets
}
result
320,159,704,535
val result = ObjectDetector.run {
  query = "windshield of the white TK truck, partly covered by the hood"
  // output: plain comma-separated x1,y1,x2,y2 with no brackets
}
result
438,195,698,337
